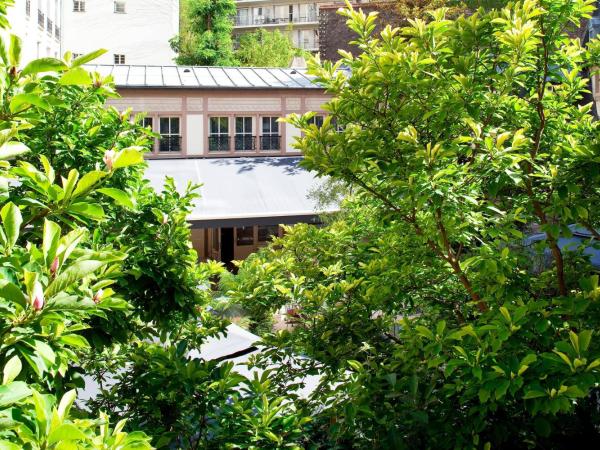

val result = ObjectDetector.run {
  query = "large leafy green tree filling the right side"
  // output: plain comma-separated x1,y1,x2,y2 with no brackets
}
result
222,0,600,448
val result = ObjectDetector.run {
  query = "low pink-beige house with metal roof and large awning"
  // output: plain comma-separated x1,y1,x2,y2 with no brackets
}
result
90,65,335,264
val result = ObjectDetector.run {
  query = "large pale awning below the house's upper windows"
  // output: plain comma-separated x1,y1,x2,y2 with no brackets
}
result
146,157,336,228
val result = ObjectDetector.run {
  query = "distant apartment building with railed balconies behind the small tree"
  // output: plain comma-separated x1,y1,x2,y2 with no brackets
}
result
233,0,340,52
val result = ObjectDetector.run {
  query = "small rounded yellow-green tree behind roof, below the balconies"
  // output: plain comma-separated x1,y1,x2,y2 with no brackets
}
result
235,28,297,67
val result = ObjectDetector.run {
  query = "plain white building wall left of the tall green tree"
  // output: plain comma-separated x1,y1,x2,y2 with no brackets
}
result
64,0,179,65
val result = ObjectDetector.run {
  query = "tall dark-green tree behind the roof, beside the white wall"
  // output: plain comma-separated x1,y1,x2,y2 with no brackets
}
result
171,0,236,66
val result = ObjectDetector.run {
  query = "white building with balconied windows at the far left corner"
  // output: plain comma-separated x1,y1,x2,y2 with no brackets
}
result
7,0,63,65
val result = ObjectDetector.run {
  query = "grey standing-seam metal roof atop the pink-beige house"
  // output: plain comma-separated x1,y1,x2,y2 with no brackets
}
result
86,64,322,89
